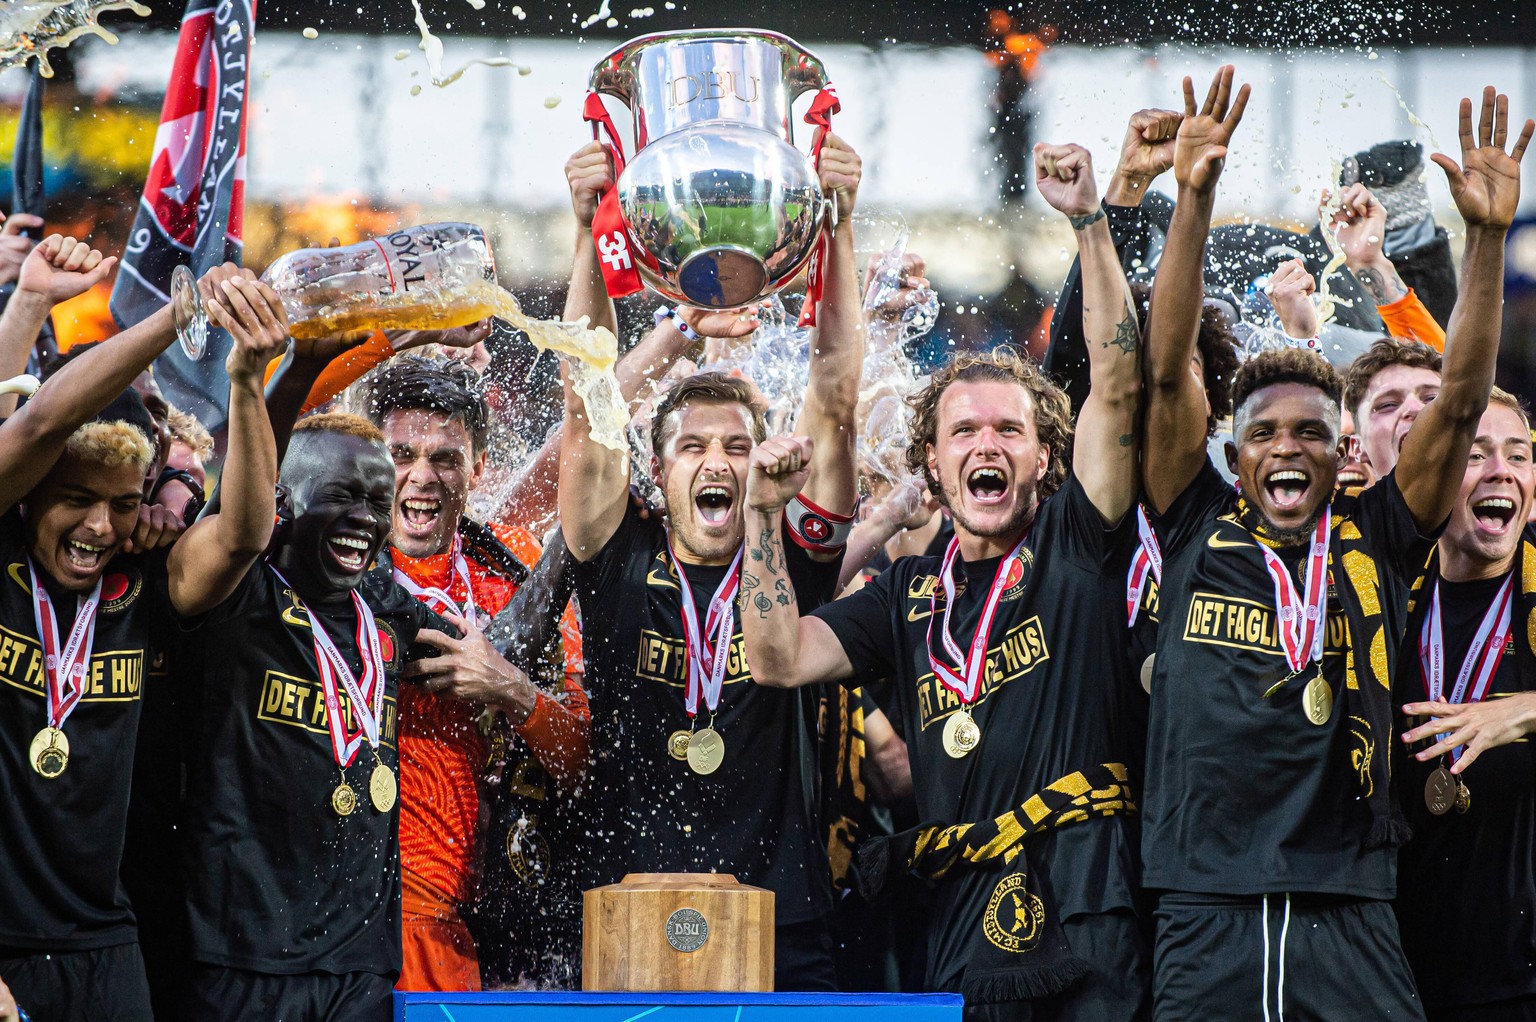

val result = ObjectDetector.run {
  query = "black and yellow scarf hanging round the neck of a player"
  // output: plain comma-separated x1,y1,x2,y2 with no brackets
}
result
1235,490,1412,848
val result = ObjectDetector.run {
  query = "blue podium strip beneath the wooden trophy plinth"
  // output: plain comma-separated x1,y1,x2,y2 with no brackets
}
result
395,991,962,1022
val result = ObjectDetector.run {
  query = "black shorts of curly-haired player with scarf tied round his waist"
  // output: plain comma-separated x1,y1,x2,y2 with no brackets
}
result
965,910,1148,1022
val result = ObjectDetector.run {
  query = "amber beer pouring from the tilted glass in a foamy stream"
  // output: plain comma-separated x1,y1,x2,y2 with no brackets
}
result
289,280,630,452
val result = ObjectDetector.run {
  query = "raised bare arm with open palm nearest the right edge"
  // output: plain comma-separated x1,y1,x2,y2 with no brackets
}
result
1396,86,1536,533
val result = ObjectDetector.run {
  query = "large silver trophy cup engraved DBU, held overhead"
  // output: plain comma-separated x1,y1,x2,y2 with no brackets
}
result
590,29,826,309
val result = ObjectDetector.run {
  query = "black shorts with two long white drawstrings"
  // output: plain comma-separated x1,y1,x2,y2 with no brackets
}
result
1154,893,1424,1022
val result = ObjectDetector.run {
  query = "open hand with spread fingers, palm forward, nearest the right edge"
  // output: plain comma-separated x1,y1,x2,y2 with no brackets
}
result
1430,85,1536,231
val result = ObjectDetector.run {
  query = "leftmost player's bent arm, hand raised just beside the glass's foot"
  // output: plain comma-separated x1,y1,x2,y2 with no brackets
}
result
169,270,289,616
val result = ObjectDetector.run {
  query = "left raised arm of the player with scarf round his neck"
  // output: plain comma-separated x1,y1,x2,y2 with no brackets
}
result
1141,65,1249,512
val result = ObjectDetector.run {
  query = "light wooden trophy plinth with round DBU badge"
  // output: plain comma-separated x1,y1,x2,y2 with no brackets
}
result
582,873,774,991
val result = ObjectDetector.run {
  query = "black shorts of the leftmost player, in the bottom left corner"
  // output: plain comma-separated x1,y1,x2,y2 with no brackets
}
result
0,944,154,1022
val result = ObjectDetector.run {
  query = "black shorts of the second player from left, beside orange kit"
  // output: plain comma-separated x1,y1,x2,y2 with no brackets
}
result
181,962,395,1022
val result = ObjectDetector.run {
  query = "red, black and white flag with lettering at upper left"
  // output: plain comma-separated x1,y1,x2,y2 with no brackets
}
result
111,0,257,430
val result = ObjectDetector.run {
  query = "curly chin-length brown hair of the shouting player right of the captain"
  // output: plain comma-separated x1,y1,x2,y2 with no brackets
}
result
906,344,1072,499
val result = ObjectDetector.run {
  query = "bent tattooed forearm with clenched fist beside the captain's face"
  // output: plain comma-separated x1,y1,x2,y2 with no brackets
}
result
742,436,854,689
